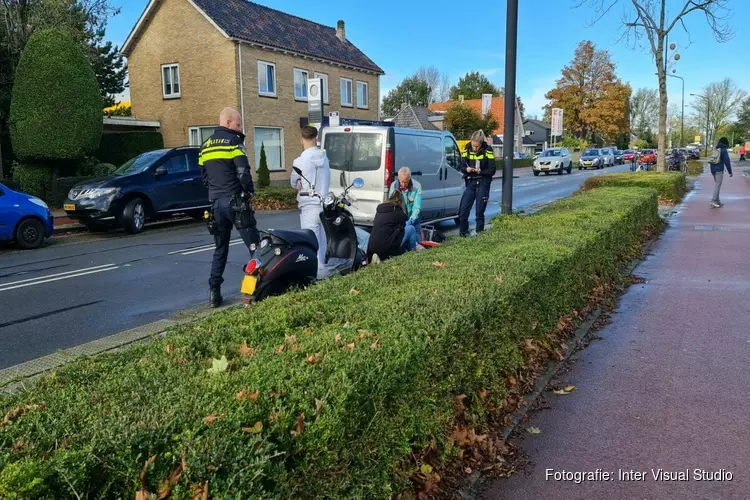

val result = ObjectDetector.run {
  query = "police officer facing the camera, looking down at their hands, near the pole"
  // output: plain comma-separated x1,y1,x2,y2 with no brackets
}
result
458,130,497,237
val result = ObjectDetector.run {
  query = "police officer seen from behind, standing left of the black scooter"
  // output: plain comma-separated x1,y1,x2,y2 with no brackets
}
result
198,108,258,307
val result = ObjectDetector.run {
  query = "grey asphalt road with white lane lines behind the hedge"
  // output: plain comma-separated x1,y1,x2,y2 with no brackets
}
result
0,166,628,369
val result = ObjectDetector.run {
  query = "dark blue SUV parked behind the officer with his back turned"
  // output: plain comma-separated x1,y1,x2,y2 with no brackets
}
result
63,147,209,234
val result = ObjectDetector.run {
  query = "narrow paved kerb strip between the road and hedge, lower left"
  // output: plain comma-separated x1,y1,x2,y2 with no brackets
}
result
0,295,240,395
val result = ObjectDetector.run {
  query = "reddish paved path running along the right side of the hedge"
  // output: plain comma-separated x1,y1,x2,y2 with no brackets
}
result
482,168,750,500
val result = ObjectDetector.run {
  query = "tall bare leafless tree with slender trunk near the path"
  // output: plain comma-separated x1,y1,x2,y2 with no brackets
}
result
574,0,733,172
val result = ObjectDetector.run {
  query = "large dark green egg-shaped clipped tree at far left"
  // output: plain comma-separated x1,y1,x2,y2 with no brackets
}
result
10,29,103,162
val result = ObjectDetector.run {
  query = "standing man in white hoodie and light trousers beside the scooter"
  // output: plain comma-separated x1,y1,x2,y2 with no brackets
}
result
291,125,331,269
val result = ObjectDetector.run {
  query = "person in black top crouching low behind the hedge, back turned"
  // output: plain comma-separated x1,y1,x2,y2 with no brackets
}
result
367,190,416,263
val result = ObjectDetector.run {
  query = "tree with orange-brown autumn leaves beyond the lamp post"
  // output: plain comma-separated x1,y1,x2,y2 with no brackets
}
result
545,41,631,142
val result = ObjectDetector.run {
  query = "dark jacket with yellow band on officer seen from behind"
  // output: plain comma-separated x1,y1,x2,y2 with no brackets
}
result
198,127,255,201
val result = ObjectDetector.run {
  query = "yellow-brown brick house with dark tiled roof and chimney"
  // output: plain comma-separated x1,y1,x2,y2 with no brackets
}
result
122,0,384,180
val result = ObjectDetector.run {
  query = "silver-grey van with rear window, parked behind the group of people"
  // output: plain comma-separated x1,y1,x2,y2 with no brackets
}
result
321,125,464,226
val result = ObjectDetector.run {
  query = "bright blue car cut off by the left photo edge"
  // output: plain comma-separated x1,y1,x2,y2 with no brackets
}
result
0,184,54,250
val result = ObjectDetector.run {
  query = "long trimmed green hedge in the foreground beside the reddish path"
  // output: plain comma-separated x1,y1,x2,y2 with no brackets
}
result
0,188,659,498
